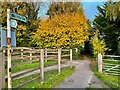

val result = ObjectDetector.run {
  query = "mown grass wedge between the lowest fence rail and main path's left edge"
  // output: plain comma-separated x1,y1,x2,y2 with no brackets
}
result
23,67,74,88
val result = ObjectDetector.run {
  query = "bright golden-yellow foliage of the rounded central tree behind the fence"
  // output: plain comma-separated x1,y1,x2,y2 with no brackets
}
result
33,13,89,48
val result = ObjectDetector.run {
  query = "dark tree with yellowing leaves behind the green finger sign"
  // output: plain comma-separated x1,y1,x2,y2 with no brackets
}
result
1,2,39,46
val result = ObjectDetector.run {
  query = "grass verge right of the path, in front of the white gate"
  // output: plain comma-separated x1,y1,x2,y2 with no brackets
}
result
91,61,120,88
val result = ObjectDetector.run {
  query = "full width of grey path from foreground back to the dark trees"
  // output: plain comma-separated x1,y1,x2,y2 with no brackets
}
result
55,56,108,89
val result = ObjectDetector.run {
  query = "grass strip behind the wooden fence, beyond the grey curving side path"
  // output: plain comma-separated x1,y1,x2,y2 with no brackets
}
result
12,60,57,73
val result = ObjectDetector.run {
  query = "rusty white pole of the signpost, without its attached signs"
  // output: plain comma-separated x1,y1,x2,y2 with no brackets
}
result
7,9,12,88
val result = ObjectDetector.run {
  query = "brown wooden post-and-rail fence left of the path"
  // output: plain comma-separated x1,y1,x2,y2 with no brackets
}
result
2,47,72,88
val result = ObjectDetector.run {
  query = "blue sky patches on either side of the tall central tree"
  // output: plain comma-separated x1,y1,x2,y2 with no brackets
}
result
38,2,104,21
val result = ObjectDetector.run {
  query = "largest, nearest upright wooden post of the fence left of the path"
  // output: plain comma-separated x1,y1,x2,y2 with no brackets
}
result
40,49,44,84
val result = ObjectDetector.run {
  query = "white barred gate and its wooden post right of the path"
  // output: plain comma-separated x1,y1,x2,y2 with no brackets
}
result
98,54,120,76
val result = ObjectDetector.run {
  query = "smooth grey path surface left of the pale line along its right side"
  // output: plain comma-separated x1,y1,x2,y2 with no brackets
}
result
55,60,93,88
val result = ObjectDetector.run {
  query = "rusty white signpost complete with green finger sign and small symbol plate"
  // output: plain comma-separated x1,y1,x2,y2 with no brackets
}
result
1,9,27,88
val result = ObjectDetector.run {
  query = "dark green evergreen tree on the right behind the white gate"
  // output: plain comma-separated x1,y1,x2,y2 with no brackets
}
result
93,2,120,54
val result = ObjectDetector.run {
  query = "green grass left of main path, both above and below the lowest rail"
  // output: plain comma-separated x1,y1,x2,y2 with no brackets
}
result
13,67,75,88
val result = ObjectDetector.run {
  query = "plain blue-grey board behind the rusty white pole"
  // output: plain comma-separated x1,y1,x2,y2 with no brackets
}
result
0,28,16,48
